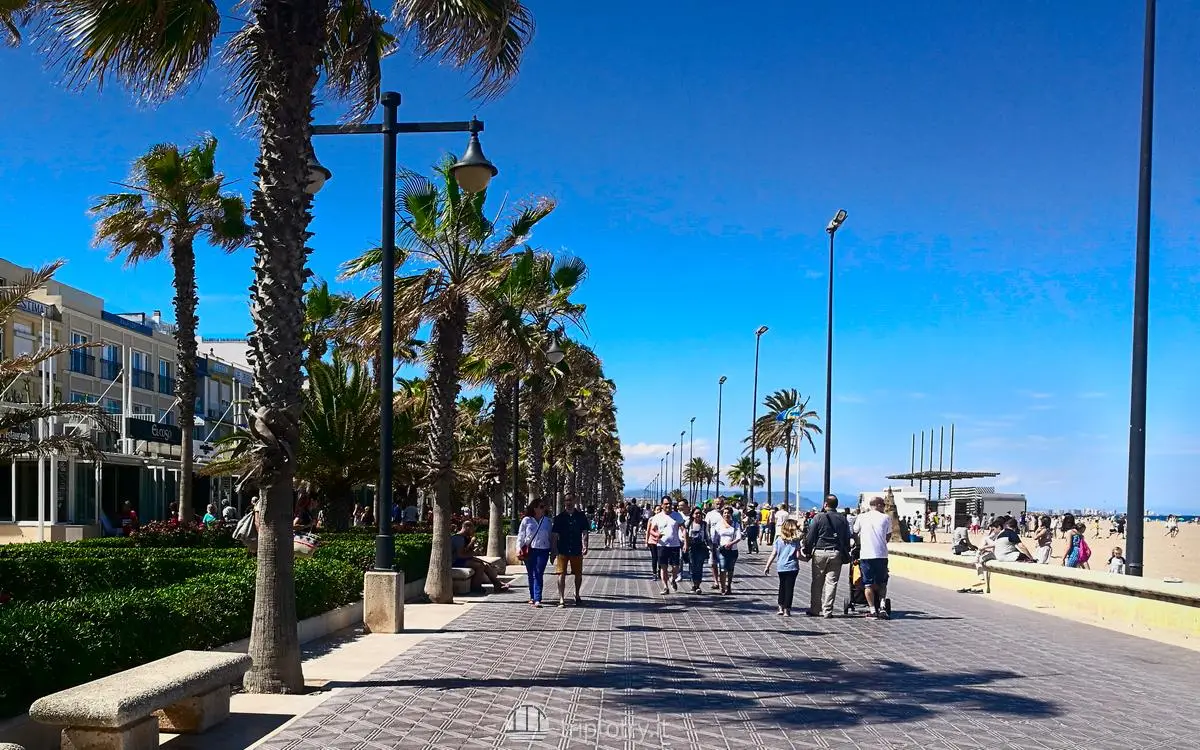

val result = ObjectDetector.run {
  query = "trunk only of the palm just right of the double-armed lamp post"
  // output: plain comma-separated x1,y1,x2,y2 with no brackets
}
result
425,296,467,604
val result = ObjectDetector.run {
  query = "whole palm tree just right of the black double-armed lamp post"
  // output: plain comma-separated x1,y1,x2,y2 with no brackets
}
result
343,160,554,604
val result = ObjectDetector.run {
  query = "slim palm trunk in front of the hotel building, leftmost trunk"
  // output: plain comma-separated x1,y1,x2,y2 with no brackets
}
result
170,234,199,521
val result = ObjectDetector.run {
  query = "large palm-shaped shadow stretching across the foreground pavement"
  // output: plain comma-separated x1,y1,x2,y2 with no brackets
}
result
326,654,1062,730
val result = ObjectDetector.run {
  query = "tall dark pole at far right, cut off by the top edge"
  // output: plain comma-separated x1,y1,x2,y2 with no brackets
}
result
1126,0,1157,576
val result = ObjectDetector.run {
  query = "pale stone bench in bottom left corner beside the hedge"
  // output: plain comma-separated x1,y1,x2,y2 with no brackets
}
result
29,652,250,750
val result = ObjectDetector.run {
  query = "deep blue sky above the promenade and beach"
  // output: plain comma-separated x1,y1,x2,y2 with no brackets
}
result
0,0,1200,512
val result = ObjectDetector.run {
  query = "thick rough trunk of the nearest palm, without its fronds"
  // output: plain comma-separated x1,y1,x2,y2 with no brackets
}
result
245,0,326,692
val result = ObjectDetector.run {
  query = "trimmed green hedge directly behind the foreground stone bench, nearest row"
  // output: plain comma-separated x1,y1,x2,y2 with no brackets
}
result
0,559,362,716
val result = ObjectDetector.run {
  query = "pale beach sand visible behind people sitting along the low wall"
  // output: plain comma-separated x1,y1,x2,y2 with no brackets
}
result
907,520,1200,583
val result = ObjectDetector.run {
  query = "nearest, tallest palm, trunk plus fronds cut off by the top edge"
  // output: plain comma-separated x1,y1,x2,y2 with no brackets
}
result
12,0,533,692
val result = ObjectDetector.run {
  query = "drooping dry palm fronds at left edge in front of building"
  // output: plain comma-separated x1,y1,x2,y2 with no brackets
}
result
0,260,115,461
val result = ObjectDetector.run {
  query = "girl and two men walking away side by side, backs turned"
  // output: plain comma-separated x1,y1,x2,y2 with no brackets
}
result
763,494,892,619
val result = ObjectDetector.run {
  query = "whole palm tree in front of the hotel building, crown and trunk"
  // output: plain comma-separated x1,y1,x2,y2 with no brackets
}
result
91,136,250,521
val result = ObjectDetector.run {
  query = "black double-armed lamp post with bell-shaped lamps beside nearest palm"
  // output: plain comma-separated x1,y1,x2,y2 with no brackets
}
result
305,91,499,570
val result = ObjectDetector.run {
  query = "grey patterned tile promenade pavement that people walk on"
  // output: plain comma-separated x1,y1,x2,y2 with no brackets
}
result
262,550,1200,750
